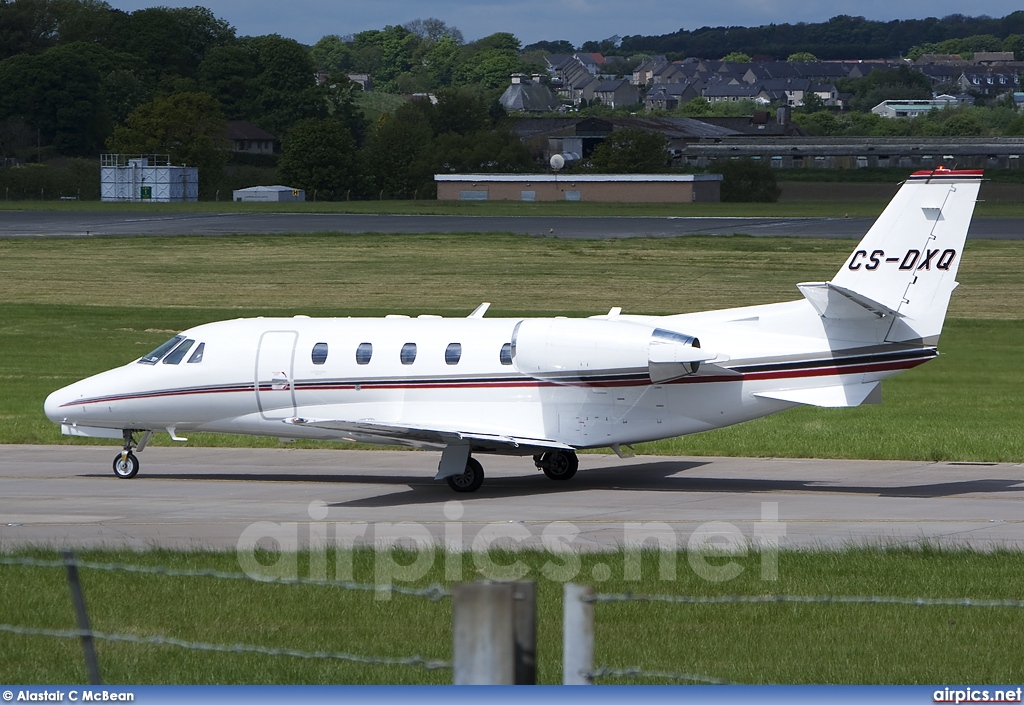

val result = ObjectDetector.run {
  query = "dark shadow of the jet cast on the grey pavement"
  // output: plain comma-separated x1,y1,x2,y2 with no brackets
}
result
96,461,1024,507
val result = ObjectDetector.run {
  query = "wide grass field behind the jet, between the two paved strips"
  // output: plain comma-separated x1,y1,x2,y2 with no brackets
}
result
0,235,1024,462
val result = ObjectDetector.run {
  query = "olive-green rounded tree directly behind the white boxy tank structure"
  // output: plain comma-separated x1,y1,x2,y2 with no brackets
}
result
106,92,230,197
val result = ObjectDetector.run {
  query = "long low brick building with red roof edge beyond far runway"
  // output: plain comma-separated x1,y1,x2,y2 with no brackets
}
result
434,174,722,203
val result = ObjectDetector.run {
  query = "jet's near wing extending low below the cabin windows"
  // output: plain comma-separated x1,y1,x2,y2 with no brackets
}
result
286,418,572,455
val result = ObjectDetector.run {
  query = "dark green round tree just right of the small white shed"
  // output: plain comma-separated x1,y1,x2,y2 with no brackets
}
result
278,118,360,201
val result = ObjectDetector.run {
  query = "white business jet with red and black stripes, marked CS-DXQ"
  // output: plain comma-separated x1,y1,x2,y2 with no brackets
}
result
45,168,982,492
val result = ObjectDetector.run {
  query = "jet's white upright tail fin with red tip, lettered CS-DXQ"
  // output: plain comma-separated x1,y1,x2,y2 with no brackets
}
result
831,168,982,344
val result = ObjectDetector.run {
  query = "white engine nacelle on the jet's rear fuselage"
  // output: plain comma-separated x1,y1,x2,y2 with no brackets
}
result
512,319,715,384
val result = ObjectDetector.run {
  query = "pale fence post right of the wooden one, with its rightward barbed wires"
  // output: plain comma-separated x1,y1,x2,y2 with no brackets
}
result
562,583,1024,685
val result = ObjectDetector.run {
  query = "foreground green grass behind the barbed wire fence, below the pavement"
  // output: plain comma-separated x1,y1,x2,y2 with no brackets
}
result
0,546,1024,685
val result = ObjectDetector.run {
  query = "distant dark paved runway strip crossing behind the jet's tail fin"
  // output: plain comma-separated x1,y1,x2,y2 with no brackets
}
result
0,211,1024,240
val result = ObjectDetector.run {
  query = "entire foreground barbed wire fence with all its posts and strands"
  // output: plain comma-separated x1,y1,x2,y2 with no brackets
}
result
0,551,1024,685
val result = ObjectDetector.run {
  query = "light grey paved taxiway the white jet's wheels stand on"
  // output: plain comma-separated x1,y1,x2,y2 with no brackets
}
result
0,445,1024,550
